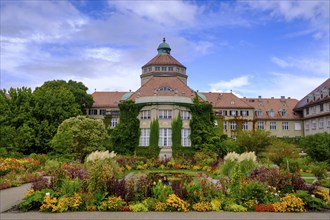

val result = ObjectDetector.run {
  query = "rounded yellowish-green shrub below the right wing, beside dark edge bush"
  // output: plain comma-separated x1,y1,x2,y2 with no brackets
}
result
262,140,299,166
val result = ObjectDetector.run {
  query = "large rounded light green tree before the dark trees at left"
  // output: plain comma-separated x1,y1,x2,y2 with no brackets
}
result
51,116,108,162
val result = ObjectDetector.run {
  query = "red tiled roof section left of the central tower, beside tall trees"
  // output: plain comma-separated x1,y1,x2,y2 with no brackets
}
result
92,92,127,107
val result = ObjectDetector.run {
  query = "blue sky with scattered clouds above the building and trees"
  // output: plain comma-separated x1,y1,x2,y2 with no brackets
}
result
0,0,330,99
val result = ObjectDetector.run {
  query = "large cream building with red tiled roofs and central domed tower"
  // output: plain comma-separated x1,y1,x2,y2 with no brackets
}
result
87,39,330,148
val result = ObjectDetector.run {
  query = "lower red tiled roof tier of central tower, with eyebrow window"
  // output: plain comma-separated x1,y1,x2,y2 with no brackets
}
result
129,76,195,100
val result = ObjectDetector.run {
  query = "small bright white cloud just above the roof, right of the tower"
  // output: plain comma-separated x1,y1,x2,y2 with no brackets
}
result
210,76,249,91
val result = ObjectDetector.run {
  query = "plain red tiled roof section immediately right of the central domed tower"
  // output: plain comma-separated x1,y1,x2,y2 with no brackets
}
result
202,92,253,108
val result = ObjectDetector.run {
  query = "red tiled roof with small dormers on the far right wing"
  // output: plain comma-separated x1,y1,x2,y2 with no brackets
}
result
242,98,300,120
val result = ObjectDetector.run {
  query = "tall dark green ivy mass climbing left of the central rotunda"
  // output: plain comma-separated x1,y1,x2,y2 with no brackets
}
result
110,100,141,155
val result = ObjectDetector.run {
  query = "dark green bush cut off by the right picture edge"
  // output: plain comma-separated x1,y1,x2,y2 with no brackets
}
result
299,133,330,163
